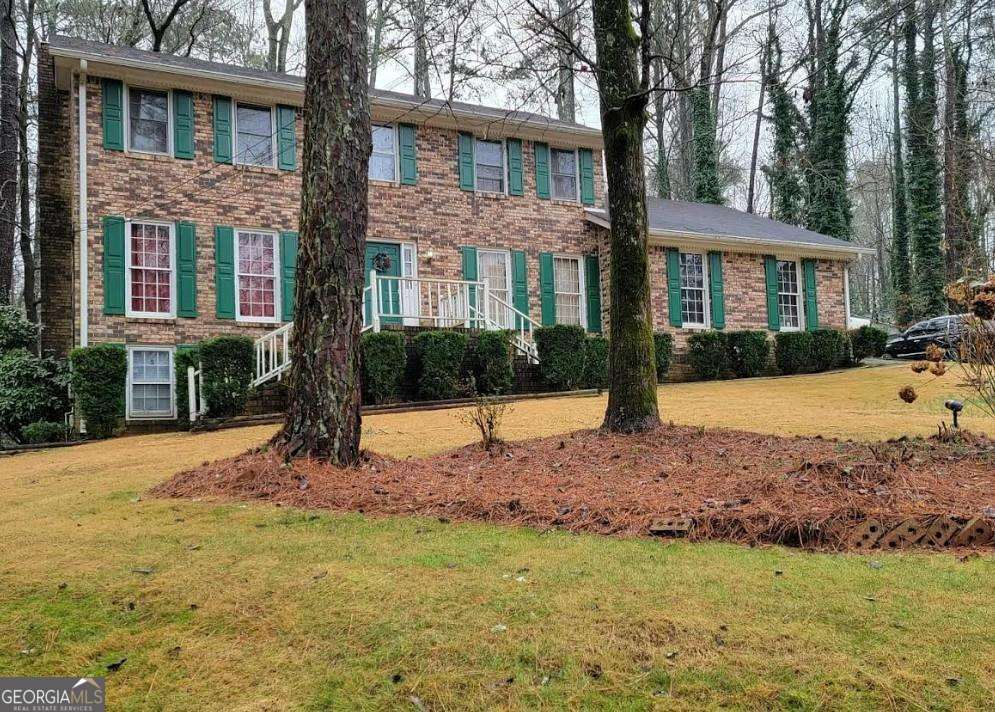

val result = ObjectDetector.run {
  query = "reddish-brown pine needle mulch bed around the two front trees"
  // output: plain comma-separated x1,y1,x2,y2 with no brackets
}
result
153,425,995,549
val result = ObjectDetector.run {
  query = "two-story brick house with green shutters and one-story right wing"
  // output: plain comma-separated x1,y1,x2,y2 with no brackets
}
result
38,37,860,421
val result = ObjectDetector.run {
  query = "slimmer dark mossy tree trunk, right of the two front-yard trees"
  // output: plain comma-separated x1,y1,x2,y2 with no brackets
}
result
594,0,660,433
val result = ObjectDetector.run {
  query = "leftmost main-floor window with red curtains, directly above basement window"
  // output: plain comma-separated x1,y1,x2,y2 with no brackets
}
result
126,222,174,317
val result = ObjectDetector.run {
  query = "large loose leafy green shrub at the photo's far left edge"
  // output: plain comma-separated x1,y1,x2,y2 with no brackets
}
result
0,349,70,441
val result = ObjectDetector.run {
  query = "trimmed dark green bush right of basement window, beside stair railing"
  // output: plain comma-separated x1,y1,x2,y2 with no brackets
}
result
197,336,256,418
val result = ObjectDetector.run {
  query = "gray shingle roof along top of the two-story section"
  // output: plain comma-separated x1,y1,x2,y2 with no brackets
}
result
49,35,601,135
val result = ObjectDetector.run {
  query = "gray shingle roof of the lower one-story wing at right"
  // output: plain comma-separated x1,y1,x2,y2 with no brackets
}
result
588,198,867,253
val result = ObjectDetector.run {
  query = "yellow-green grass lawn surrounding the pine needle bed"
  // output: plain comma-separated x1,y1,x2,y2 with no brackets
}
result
0,368,995,710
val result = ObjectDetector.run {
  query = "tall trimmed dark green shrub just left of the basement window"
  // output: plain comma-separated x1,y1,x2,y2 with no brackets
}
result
69,344,128,438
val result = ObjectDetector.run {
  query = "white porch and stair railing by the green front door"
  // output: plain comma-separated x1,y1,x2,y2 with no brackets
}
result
252,270,539,386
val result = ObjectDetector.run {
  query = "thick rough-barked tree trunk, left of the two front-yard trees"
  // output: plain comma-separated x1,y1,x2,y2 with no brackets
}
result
274,0,371,465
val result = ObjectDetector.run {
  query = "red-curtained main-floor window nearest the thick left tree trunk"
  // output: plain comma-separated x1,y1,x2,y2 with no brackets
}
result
235,230,277,321
